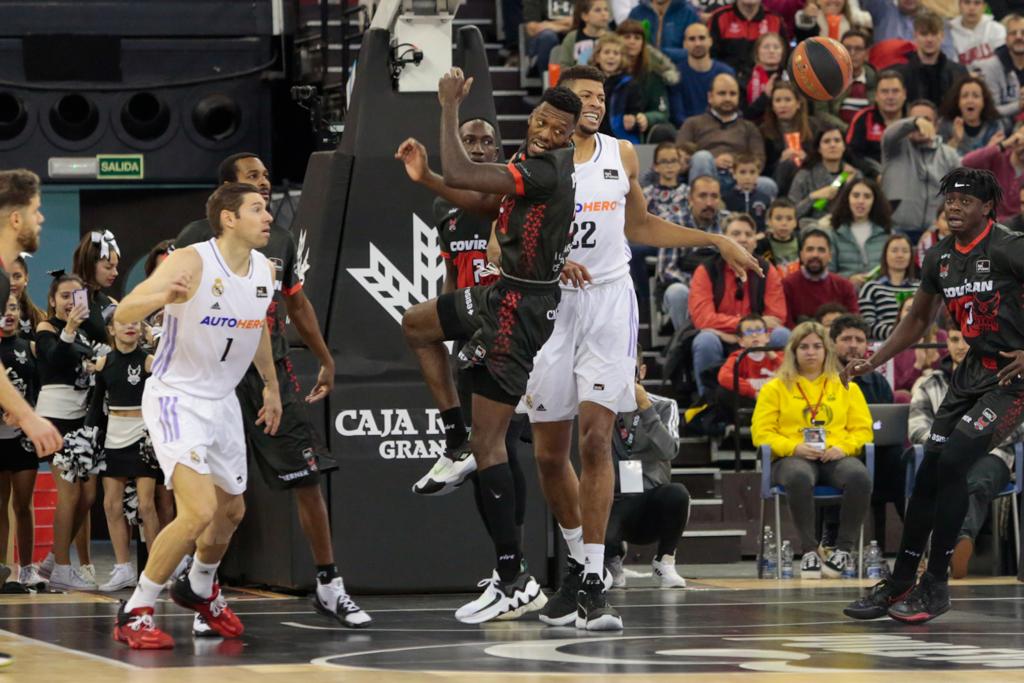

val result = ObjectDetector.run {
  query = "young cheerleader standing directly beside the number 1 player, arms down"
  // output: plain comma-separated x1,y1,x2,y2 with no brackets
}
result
85,322,164,592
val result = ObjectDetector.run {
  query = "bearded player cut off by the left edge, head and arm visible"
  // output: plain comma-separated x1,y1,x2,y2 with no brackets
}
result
0,169,63,458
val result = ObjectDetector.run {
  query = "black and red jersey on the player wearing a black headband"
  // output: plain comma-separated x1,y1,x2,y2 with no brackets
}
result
921,221,1024,362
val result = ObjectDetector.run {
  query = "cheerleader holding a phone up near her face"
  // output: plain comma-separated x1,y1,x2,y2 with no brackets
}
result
36,272,96,591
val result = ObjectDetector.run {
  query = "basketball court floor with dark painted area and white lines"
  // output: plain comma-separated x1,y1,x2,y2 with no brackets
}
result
0,578,1024,683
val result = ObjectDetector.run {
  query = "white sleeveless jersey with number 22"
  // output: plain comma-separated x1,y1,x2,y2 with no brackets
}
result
567,133,631,289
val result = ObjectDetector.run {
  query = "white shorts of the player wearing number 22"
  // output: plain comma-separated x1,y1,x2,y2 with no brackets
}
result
516,274,640,422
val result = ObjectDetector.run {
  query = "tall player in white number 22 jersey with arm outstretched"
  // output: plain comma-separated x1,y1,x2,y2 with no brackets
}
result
519,66,760,631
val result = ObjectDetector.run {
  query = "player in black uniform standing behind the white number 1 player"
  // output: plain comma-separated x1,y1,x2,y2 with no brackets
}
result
174,153,372,636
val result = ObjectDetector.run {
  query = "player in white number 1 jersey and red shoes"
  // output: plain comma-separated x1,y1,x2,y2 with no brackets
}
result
114,183,282,649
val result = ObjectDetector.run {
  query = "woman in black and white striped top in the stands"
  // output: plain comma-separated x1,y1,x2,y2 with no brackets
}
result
858,234,921,342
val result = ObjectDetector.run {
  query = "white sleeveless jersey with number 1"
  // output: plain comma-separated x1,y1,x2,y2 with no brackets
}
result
153,240,273,399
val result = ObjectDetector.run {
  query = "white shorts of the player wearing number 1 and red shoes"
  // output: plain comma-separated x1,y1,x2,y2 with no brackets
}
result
142,377,249,496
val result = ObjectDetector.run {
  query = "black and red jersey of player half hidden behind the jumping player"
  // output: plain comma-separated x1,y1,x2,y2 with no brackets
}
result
434,198,497,290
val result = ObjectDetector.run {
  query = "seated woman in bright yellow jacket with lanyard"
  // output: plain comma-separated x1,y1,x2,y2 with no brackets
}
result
753,323,873,579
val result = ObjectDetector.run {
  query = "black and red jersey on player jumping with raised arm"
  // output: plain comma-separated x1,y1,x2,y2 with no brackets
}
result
495,145,575,282
